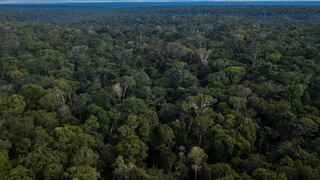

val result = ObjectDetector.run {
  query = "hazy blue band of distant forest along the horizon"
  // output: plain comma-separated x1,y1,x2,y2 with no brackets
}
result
0,5,320,24
